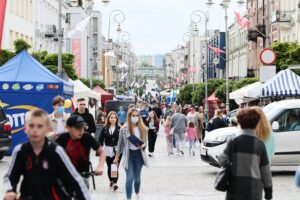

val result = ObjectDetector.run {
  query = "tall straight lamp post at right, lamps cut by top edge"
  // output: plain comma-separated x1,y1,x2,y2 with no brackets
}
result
206,0,245,111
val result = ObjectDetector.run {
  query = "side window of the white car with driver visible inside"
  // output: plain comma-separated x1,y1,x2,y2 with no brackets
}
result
274,108,300,132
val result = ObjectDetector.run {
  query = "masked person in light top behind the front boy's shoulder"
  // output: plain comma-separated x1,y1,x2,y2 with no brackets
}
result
47,96,70,141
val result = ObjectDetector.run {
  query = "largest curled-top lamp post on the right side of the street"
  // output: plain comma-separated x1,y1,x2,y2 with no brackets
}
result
191,10,209,124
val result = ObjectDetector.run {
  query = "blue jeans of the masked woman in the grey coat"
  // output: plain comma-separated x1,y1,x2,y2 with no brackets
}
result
125,150,144,199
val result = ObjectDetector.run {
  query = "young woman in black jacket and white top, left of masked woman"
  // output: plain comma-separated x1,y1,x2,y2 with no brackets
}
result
99,111,122,191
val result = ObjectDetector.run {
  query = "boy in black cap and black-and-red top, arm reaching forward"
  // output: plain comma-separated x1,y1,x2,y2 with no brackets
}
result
56,115,106,188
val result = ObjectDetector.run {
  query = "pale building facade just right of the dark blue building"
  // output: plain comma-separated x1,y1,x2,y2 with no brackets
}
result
228,16,248,80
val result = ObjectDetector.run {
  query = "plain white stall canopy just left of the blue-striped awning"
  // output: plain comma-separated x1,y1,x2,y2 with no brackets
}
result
229,82,261,105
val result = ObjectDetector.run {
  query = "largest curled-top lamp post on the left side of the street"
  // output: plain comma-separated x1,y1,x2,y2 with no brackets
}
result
104,10,125,86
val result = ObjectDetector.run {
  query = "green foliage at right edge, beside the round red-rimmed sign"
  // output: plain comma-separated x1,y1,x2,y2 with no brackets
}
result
272,42,300,72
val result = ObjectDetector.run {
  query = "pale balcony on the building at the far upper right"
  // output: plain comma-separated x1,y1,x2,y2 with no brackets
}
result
272,10,293,29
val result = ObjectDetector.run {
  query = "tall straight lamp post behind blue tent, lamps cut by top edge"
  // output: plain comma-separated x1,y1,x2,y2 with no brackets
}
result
57,0,110,78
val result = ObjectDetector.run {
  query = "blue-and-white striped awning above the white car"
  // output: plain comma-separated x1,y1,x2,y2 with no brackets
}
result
261,69,300,97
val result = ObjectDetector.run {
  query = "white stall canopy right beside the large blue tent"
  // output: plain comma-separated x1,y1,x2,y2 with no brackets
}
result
73,80,101,101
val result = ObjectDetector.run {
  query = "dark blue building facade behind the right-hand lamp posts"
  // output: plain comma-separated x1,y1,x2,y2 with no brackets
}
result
207,32,226,78
